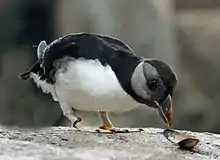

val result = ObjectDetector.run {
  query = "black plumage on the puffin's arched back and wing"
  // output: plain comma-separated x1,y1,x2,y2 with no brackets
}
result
22,33,141,84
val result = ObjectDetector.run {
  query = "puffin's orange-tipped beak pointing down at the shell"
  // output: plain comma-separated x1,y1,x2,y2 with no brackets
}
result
157,95,173,127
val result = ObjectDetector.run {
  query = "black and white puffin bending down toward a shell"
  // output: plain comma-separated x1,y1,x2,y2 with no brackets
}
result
18,32,177,133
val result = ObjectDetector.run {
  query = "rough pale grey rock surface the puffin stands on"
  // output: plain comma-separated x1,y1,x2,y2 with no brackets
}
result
0,127,220,160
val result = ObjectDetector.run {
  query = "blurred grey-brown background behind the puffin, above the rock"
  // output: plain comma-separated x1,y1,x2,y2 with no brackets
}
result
0,0,220,133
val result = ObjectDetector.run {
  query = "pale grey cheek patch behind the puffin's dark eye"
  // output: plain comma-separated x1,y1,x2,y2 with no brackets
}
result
131,62,150,99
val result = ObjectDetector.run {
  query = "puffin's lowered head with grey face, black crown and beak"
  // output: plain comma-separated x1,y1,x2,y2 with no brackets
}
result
131,59,177,126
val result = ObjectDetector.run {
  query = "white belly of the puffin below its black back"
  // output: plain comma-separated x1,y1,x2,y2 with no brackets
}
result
32,60,138,112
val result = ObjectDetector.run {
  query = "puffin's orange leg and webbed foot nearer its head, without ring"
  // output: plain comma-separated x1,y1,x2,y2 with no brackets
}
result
97,111,142,133
